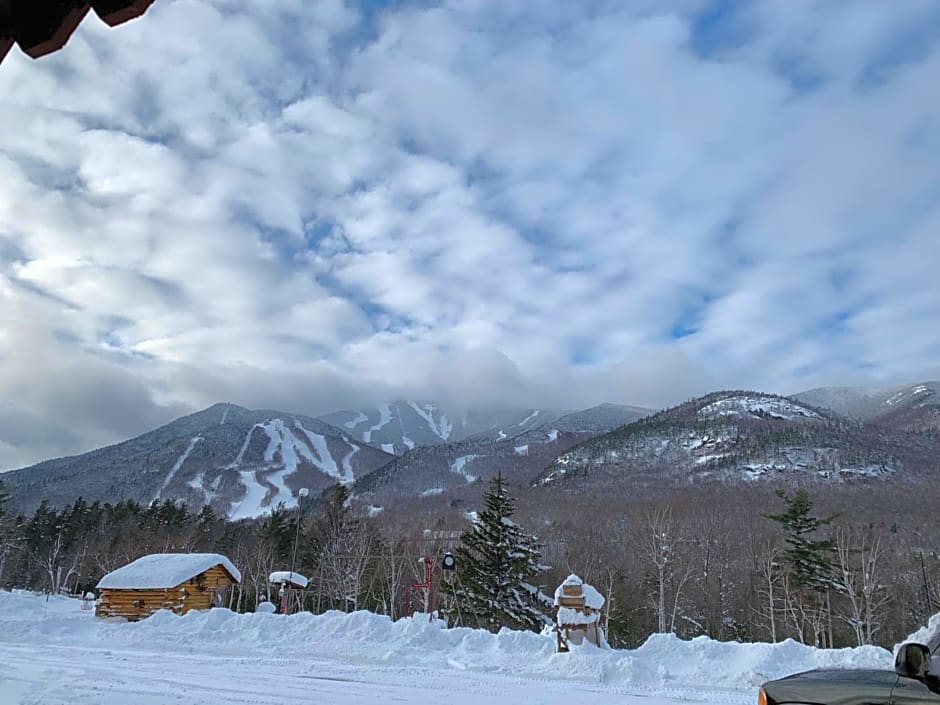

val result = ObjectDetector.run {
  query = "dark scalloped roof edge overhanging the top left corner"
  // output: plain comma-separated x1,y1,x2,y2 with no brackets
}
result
0,0,154,62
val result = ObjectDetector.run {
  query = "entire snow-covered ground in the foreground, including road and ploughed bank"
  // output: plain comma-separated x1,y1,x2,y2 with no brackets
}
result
0,592,892,705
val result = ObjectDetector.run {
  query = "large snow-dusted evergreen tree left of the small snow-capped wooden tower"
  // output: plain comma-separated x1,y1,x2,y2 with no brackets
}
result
443,474,550,632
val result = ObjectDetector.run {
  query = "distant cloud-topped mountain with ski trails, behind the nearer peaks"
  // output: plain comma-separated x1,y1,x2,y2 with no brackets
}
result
320,401,569,455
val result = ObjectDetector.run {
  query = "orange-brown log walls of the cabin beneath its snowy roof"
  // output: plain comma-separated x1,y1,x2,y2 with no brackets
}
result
95,566,235,621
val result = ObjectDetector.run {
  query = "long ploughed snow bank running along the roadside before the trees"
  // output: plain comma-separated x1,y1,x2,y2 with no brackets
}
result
0,592,893,699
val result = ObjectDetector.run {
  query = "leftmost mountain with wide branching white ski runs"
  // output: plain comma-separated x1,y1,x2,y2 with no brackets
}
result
2,404,392,519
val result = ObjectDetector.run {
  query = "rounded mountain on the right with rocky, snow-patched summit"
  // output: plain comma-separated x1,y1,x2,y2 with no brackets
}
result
536,391,937,487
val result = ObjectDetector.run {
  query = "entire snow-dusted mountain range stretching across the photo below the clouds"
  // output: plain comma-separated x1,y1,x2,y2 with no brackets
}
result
0,382,940,519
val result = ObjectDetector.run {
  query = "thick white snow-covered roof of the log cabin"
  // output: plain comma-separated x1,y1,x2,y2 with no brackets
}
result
98,553,242,590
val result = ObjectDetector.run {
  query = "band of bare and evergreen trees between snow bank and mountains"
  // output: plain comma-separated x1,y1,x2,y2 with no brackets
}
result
0,475,940,647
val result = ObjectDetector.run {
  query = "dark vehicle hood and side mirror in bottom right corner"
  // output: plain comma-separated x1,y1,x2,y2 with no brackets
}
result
758,644,940,705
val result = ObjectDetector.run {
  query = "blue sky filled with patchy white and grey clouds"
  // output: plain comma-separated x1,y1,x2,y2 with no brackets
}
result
0,0,940,469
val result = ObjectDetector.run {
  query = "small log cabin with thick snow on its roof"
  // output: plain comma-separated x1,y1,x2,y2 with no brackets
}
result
95,553,241,621
